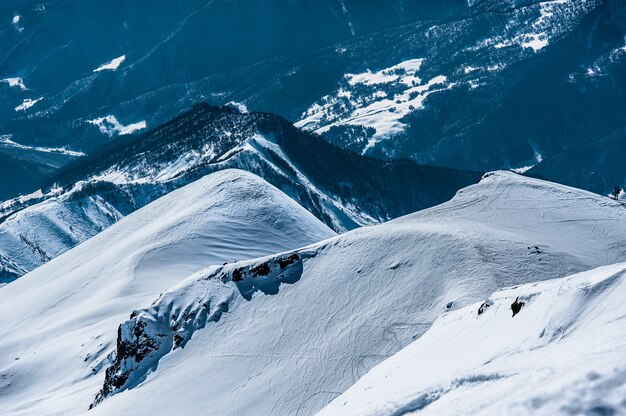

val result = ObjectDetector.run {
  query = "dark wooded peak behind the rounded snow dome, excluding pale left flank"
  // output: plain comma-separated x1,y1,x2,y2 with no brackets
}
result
44,104,480,230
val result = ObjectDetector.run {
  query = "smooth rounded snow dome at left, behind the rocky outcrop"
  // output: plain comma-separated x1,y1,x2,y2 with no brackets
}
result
0,170,334,414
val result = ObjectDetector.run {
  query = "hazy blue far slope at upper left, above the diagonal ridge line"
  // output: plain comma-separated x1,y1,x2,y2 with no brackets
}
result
0,0,467,159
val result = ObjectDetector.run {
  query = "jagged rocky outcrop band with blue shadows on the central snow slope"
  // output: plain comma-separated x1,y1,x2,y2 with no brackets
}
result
92,250,314,407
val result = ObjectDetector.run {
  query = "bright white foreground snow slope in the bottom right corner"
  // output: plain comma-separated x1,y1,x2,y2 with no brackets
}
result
318,263,626,416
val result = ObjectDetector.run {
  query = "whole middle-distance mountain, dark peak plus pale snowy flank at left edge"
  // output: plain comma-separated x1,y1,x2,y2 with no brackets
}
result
0,104,480,283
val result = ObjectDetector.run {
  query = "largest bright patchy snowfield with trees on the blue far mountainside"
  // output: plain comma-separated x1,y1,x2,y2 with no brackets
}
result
296,59,454,152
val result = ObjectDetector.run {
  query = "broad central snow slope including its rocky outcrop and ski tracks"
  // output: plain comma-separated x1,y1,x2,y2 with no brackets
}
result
74,172,626,415
